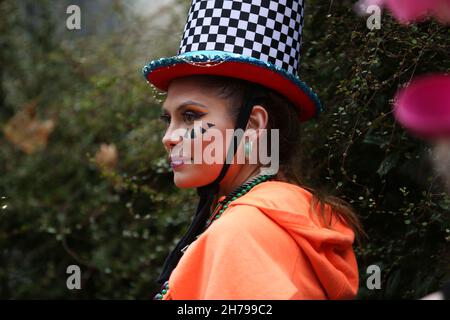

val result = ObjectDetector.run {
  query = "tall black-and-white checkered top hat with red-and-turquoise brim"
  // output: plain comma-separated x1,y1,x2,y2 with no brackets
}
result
143,0,322,121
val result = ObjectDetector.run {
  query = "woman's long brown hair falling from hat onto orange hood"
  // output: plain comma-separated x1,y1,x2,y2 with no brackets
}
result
181,75,367,246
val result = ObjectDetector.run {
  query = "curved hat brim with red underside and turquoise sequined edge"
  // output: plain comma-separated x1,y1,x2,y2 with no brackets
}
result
142,51,323,121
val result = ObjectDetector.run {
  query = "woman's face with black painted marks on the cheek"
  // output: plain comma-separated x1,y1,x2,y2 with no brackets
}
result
161,78,234,188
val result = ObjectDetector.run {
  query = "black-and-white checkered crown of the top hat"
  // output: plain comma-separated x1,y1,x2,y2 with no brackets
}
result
178,0,304,75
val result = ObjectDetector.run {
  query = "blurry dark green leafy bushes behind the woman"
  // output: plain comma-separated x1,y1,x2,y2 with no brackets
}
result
0,0,450,299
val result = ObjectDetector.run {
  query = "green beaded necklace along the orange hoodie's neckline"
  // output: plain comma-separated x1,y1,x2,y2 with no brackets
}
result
153,174,274,300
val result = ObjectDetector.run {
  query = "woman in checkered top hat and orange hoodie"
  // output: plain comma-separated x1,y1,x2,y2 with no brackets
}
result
144,0,361,299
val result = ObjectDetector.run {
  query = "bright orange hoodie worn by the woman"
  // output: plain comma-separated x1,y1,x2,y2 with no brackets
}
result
163,181,358,300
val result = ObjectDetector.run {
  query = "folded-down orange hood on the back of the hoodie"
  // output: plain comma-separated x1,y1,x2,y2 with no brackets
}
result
229,181,359,299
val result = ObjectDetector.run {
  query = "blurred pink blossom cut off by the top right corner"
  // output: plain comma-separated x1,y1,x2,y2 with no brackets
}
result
360,0,450,23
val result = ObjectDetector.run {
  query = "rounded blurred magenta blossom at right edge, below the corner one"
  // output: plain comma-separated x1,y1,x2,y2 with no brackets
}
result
394,74,450,139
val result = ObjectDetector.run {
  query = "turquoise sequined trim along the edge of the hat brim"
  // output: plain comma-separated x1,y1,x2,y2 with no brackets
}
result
142,50,324,120
